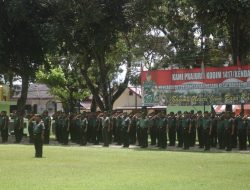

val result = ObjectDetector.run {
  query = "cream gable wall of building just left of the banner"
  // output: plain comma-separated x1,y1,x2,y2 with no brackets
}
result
113,88,142,109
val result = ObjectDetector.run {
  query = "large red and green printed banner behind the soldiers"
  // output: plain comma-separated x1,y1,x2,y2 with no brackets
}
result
141,66,250,106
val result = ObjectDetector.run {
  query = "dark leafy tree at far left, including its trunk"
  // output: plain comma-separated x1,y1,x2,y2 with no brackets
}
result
0,0,55,113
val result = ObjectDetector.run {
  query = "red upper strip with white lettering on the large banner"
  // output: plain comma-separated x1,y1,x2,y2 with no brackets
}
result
141,66,250,86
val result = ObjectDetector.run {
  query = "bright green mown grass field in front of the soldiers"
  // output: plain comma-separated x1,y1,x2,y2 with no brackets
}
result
0,145,250,190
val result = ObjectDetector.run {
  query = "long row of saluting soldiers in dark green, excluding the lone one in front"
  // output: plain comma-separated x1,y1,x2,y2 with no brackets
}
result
0,108,250,151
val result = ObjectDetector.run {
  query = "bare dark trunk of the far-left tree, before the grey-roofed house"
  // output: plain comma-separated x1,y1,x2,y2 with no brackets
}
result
17,76,29,114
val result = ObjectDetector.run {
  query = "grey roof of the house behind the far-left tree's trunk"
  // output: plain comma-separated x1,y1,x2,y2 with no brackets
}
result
12,84,54,99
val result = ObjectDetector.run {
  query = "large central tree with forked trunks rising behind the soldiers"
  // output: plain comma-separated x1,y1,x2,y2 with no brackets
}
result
51,0,161,110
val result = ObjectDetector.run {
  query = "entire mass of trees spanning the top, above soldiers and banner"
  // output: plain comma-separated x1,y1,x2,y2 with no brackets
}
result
0,0,250,110
